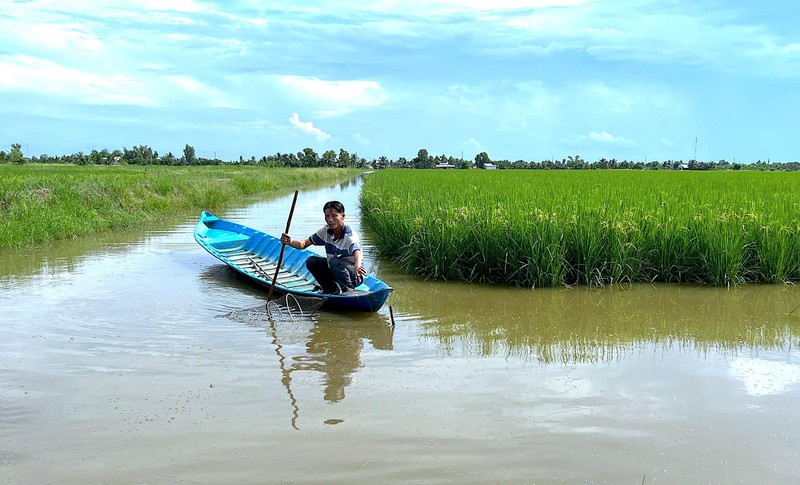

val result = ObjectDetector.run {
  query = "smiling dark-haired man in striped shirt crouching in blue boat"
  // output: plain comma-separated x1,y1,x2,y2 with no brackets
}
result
281,200,367,295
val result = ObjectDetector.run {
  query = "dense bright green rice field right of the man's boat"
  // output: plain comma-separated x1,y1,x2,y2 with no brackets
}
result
360,170,800,287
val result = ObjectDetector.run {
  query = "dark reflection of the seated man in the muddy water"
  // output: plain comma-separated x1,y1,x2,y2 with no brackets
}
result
292,319,392,402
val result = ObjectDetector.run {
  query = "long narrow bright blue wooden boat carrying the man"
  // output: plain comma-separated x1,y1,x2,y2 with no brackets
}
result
194,211,392,312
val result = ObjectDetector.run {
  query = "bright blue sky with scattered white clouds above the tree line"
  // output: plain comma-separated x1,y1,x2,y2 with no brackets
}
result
0,0,800,163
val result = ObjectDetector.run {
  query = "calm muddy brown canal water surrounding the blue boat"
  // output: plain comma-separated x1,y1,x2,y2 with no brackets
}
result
0,176,800,484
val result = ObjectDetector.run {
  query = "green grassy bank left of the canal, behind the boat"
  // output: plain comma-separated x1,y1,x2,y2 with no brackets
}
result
0,164,358,248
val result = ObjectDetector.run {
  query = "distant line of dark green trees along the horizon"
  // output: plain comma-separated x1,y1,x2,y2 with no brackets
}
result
0,143,800,171
